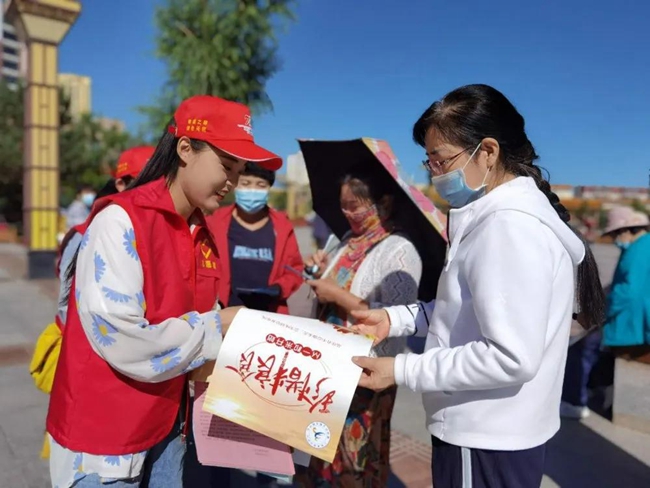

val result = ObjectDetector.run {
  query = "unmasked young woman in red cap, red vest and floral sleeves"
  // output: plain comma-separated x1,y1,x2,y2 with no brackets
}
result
47,96,282,488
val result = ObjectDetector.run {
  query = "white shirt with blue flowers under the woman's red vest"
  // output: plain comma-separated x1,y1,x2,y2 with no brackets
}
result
50,205,222,488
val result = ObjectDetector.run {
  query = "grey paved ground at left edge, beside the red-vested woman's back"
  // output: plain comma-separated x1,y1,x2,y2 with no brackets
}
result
0,244,56,488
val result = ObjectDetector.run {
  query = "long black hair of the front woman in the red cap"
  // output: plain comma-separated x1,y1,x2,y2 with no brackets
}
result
65,119,210,292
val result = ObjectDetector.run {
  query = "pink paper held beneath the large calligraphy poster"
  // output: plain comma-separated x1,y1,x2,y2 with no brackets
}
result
193,382,295,475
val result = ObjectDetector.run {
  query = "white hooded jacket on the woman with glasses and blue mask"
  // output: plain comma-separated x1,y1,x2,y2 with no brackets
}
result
388,178,585,450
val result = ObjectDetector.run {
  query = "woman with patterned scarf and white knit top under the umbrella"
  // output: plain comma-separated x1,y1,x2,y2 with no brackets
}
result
300,171,422,488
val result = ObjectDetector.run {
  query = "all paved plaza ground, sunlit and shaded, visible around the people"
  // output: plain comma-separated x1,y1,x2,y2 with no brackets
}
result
0,245,650,488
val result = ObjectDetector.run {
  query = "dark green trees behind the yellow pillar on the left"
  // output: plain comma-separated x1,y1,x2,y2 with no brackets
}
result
0,80,138,222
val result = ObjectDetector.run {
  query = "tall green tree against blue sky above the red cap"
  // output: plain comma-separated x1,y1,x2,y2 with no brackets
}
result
141,0,294,135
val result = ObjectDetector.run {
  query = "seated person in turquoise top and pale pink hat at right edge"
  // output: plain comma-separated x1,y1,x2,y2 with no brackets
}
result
561,206,650,419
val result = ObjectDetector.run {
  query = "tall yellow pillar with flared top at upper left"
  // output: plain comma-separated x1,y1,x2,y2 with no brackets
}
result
5,0,81,278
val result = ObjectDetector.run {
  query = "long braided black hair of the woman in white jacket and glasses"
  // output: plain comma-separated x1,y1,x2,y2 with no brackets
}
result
413,85,605,327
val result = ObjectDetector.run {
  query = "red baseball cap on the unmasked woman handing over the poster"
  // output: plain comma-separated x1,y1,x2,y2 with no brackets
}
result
169,95,282,171
